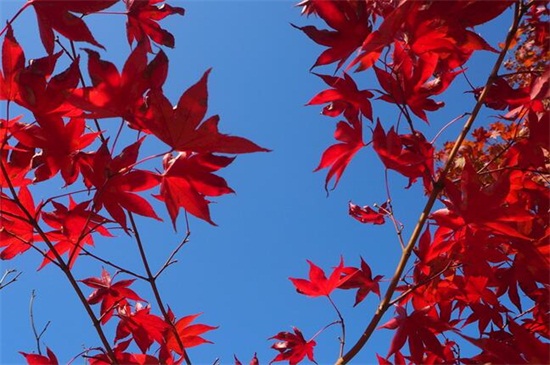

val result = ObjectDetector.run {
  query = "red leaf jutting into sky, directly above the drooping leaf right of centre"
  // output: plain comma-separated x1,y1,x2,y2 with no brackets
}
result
306,73,373,120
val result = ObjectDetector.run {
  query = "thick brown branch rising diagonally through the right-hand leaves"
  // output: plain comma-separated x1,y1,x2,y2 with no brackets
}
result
336,3,523,365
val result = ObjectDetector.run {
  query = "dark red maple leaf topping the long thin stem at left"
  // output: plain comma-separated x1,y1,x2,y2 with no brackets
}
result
82,137,161,230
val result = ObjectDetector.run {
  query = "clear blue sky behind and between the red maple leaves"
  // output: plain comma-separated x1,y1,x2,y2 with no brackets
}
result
0,0,510,365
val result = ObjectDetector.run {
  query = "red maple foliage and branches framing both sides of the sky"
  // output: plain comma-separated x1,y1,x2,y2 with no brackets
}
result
0,0,550,365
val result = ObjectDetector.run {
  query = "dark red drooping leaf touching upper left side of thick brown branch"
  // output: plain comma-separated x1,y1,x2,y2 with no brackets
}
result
372,121,434,191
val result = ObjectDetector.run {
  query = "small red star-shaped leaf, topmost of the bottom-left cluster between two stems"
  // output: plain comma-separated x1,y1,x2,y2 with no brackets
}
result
81,269,144,324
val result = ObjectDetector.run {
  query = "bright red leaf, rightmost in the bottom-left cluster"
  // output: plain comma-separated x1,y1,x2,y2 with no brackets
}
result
166,313,218,355
